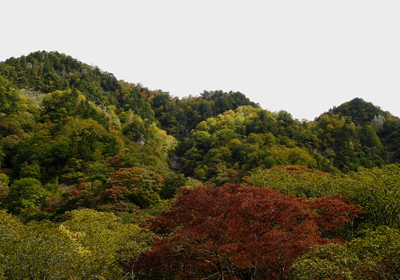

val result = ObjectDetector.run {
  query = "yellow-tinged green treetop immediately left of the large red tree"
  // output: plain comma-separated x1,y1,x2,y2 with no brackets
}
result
61,209,152,279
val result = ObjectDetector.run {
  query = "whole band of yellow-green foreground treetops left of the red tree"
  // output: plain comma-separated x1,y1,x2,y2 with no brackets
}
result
0,210,152,280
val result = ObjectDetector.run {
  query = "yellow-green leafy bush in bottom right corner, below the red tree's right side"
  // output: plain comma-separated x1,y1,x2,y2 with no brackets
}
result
291,227,400,280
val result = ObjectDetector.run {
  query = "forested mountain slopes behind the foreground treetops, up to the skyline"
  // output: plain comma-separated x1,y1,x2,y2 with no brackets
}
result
0,51,400,219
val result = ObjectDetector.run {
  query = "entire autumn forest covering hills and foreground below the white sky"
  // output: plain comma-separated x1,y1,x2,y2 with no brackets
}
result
0,51,400,279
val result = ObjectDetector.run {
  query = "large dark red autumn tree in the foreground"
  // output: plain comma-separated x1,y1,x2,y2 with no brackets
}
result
127,184,361,279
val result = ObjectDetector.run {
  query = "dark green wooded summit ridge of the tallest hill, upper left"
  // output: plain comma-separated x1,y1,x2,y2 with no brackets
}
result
0,51,154,120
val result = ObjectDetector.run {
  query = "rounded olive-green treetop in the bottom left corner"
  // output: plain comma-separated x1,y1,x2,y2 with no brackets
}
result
0,223,81,279
